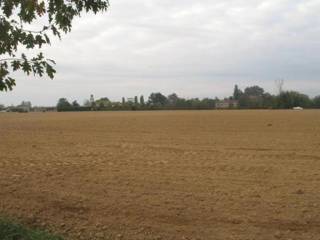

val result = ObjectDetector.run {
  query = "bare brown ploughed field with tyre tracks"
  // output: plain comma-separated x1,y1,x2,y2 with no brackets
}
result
0,110,320,240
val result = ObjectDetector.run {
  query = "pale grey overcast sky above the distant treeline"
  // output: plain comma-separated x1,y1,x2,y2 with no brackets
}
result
0,0,320,105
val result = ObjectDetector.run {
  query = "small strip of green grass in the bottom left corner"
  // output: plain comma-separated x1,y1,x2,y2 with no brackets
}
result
0,218,63,240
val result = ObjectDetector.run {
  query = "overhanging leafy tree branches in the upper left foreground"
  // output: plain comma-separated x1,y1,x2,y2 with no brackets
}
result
0,0,109,91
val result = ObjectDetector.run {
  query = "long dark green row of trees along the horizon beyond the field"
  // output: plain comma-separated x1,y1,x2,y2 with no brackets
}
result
57,85,320,111
